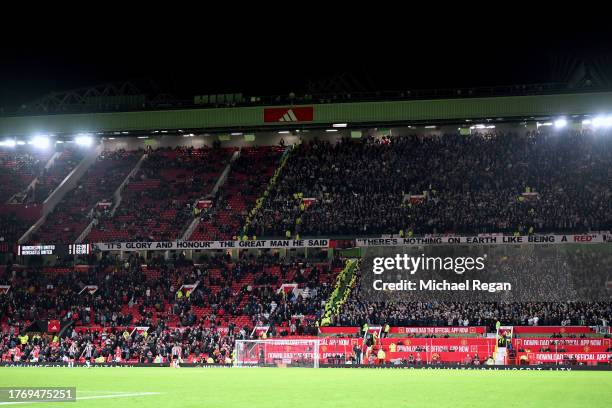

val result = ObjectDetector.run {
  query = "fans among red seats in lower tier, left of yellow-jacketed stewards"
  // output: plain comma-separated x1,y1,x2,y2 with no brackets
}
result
0,254,342,362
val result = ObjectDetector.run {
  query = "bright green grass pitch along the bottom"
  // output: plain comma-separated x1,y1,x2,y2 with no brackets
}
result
0,368,612,408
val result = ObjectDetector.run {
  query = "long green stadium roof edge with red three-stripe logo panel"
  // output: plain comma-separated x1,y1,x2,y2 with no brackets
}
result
0,92,612,137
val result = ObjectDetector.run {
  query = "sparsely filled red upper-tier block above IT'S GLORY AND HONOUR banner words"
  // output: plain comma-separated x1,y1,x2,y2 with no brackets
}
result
87,148,235,242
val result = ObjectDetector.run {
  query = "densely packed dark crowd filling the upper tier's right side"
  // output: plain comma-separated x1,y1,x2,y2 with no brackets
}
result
245,130,612,236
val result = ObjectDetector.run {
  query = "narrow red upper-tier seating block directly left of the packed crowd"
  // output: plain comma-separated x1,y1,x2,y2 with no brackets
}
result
189,146,284,241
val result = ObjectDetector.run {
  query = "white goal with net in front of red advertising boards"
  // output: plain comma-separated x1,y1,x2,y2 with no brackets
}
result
234,339,320,368
